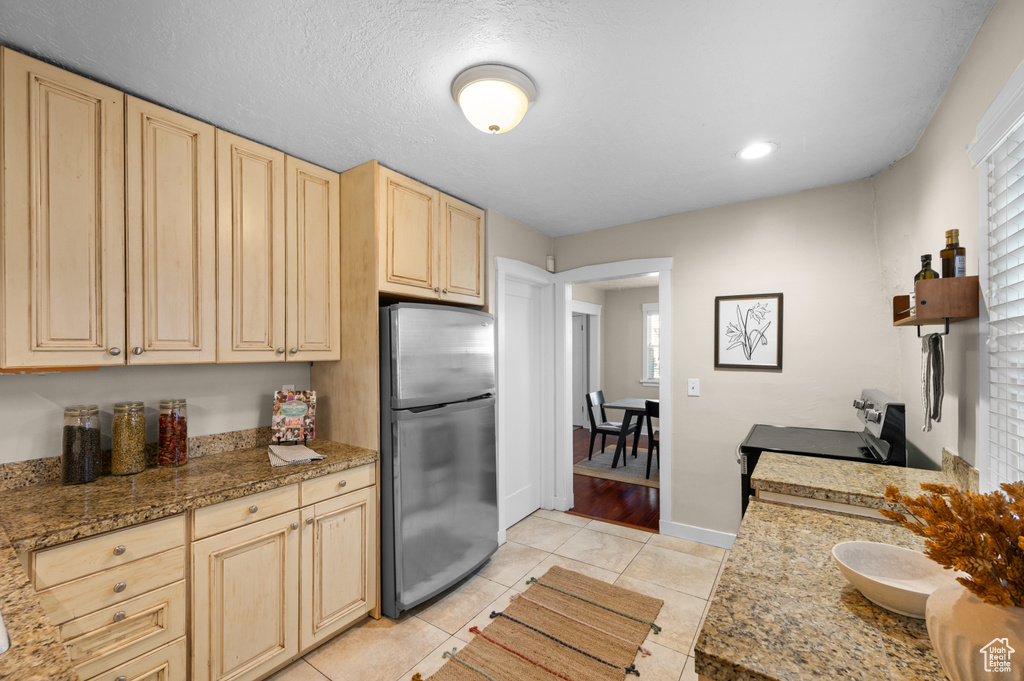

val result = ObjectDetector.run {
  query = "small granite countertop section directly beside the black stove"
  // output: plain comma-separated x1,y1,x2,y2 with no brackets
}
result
751,452,952,508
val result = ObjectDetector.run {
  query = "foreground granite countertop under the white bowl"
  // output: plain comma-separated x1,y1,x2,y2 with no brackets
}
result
694,500,946,681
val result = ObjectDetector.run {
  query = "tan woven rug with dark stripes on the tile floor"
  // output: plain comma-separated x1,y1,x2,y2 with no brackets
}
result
414,566,664,681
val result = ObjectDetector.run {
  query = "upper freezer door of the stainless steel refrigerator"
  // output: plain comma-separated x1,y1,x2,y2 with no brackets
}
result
382,303,495,409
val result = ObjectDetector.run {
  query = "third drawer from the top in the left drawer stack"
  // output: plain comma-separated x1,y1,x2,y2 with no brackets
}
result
60,581,185,679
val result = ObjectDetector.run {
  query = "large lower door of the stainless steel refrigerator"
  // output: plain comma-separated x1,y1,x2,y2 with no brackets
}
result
381,397,498,616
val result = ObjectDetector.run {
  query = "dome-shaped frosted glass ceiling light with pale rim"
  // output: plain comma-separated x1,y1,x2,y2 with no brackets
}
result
452,63,537,135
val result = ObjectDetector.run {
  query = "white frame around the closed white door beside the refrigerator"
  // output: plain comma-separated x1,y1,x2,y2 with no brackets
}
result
495,257,557,544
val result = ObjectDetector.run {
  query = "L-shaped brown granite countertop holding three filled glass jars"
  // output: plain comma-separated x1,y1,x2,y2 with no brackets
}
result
0,440,378,681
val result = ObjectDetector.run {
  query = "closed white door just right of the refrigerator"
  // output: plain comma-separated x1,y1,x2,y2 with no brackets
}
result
499,278,550,527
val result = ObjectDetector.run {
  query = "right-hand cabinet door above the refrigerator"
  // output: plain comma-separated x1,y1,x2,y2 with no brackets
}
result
439,195,484,305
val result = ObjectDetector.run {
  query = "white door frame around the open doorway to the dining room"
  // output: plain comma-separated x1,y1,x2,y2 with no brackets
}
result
541,258,672,520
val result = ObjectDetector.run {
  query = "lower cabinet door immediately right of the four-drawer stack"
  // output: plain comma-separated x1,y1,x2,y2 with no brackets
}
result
191,511,300,681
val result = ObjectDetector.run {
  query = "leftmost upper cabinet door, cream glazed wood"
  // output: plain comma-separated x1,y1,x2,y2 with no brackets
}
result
0,49,125,368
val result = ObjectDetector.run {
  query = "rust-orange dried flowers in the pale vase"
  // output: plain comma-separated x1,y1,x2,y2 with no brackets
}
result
881,482,1024,607
